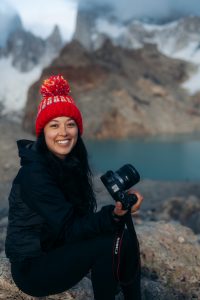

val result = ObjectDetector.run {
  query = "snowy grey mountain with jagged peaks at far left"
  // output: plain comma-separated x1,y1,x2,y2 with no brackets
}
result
0,1,63,117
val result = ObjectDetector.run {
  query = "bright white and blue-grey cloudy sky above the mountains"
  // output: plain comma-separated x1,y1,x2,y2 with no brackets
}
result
4,0,200,40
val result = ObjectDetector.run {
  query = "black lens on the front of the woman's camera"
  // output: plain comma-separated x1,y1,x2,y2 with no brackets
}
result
116,164,140,190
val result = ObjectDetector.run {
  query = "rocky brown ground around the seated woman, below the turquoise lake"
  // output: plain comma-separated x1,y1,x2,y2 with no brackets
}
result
0,119,200,300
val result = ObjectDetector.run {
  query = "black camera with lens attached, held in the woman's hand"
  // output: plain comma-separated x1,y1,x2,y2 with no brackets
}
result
100,164,140,210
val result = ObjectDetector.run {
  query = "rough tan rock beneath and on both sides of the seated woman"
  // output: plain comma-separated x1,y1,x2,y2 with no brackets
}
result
0,222,200,300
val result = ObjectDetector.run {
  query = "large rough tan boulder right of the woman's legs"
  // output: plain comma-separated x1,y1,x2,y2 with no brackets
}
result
137,222,200,300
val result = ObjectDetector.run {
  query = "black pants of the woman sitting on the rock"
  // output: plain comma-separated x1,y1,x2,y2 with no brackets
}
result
11,233,141,300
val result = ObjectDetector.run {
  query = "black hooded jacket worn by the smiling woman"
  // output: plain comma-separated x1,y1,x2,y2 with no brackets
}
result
5,140,117,261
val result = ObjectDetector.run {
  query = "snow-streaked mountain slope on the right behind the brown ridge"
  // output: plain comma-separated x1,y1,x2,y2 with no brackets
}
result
74,11,200,94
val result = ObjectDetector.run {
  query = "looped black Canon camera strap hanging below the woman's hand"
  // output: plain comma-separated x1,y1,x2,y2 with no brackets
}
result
113,213,141,285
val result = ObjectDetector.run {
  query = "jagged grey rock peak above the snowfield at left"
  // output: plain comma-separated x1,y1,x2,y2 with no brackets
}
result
0,26,63,72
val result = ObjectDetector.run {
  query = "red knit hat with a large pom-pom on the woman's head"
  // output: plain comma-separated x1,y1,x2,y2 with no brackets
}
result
35,75,83,136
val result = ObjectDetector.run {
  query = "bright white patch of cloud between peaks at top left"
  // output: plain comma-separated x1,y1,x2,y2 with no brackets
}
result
8,0,77,40
